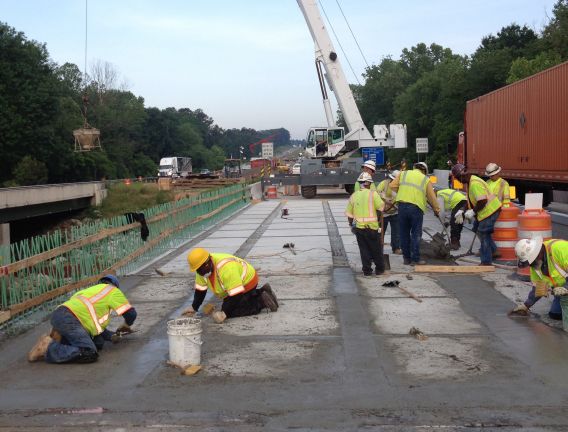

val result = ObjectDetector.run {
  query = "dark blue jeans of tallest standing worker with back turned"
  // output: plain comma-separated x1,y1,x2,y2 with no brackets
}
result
398,202,424,262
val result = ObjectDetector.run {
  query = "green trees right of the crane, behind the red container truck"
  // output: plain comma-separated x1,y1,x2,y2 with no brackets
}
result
352,0,568,168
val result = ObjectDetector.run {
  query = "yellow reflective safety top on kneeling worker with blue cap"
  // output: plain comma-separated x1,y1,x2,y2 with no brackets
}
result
62,284,132,336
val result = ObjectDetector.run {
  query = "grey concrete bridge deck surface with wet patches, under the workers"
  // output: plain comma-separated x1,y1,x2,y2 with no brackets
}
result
0,194,568,431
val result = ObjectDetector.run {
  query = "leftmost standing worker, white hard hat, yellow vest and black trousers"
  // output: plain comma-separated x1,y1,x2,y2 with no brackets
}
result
345,172,385,276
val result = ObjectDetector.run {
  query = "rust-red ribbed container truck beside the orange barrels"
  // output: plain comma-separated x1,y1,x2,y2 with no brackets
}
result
458,62,568,205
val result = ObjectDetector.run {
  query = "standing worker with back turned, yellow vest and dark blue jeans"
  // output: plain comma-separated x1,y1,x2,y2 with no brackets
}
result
390,162,440,265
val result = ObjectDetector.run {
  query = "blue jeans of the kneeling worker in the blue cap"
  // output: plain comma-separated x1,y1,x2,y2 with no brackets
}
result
45,306,97,363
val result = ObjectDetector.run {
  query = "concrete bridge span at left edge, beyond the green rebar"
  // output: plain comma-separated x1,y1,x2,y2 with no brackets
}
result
0,181,107,245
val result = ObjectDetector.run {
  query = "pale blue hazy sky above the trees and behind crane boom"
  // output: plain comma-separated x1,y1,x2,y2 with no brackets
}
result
0,0,555,138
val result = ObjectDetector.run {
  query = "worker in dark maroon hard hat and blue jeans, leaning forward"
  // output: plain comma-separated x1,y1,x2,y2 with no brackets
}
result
452,163,501,265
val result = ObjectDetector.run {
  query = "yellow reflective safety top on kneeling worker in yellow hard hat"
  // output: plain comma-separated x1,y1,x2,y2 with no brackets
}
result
195,253,256,299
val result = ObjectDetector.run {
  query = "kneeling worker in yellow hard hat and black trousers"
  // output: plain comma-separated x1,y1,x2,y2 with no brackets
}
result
183,248,278,324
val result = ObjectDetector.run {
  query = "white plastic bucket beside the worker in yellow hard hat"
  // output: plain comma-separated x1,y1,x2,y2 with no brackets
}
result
168,318,202,368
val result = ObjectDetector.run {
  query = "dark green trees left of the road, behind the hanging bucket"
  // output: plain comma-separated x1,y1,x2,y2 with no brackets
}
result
0,22,290,186
